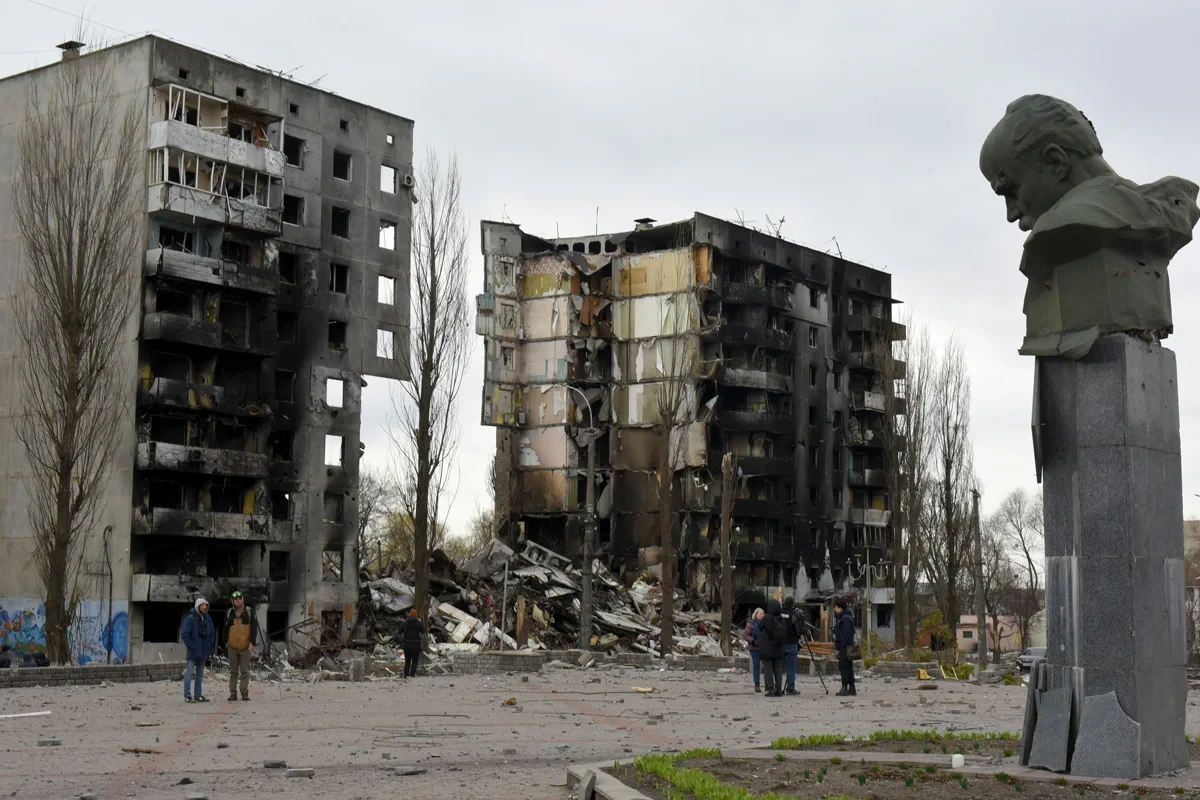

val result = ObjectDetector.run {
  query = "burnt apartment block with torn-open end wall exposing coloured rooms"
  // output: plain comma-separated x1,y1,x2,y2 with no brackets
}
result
476,213,905,637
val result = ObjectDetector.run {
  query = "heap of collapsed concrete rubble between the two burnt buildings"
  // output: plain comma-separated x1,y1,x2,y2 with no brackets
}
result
355,540,744,656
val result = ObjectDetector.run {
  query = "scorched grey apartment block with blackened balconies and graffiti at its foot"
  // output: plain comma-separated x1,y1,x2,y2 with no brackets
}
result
0,36,413,662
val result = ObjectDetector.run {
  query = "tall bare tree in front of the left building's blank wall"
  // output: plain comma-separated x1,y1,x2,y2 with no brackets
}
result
12,45,145,663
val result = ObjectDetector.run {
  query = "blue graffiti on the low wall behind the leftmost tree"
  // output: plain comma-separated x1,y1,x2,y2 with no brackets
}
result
0,597,130,664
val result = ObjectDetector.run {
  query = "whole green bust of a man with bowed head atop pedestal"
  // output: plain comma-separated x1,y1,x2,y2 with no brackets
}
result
979,95,1200,359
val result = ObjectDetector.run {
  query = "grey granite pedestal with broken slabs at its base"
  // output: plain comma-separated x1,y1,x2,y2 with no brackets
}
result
1021,333,1188,778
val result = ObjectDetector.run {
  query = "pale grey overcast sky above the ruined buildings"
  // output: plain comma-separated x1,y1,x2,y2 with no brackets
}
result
0,0,1200,531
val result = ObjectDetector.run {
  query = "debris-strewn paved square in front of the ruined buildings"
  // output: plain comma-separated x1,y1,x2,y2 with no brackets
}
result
0,668,1200,800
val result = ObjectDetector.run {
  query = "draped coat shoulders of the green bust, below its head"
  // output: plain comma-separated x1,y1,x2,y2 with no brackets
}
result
1025,175,1200,258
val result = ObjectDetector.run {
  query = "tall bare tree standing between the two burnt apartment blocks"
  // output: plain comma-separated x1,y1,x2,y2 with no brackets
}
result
388,150,472,609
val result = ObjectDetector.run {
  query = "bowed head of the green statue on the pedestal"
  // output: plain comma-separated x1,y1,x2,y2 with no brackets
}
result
979,95,1104,230
